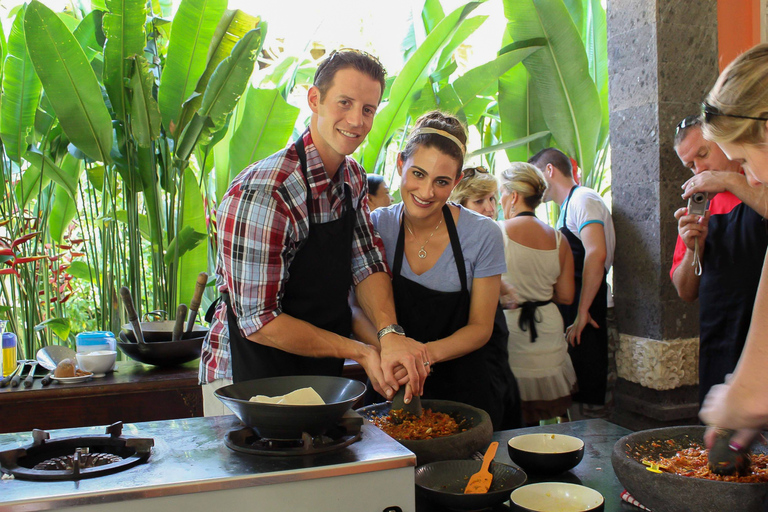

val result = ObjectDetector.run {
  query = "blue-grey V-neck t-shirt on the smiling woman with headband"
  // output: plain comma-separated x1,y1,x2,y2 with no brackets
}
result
371,203,507,292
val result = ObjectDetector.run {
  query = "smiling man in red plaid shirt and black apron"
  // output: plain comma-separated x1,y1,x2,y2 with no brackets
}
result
200,50,429,410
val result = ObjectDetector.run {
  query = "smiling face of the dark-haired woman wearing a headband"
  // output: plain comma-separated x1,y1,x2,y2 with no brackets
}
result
397,146,461,219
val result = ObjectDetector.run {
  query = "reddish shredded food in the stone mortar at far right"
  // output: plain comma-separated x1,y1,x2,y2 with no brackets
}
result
641,443,768,483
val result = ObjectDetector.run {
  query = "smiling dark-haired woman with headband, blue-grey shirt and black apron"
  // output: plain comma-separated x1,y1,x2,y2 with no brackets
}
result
356,111,520,430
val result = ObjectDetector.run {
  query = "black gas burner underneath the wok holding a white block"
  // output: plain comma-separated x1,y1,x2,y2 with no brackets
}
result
225,410,363,457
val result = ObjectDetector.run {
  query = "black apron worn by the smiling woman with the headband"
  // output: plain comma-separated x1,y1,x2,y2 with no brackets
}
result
392,205,519,430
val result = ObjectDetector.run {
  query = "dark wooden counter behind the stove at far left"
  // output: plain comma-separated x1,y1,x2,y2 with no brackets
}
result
0,361,203,433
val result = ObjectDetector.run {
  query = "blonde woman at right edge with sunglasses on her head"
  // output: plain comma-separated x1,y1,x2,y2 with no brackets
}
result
699,44,768,446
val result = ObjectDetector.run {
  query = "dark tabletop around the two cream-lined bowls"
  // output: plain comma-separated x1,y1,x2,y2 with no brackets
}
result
416,420,640,512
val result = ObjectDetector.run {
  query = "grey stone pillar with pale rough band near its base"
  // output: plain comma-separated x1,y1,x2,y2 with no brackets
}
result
607,0,718,428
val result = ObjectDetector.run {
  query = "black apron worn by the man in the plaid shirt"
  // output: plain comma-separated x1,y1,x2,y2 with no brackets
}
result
223,138,355,382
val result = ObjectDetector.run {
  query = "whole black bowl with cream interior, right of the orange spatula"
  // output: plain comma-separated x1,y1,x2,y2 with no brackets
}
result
507,434,584,476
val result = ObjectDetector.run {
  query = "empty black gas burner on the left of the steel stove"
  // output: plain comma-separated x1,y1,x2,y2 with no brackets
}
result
0,422,155,481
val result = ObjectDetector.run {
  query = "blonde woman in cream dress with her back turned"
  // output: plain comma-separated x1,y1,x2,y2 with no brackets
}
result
499,162,576,425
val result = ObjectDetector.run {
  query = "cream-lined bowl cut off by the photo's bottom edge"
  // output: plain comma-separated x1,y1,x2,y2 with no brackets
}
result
509,482,605,512
